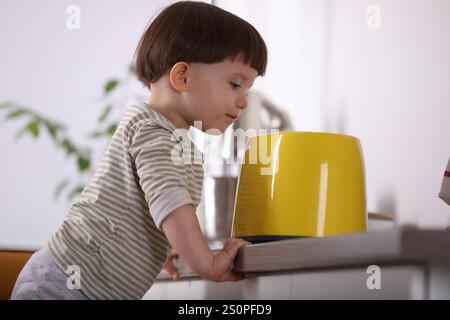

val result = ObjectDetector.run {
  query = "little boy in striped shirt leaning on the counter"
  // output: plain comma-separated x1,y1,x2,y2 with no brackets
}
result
12,1,267,299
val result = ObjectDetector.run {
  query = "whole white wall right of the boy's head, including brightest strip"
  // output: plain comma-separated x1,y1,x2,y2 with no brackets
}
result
216,0,450,228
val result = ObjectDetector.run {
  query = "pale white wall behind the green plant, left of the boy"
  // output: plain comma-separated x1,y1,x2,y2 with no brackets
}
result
0,0,176,248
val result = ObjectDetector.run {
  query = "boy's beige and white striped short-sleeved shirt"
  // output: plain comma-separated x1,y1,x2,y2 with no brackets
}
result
48,103,203,299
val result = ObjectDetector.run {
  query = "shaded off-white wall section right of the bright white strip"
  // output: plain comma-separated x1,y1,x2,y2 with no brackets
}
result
324,0,450,227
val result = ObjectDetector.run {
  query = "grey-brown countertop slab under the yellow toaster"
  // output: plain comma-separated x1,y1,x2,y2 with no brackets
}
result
156,226,450,281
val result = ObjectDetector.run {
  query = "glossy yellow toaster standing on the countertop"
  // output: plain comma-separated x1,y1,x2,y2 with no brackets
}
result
231,132,367,242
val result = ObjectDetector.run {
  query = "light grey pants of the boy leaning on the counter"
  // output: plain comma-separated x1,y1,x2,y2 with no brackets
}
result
11,246,89,300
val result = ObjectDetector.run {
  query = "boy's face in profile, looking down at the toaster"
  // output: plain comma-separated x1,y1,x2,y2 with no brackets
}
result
185,59,258,133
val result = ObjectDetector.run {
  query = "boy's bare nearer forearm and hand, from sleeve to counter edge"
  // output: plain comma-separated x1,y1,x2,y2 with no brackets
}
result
162,205,248,281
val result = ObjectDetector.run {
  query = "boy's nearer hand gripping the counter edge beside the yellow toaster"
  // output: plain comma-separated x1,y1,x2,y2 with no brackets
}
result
208,239,250,282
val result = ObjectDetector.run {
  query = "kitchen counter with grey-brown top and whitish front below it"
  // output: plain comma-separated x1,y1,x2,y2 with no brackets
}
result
144,226,450,300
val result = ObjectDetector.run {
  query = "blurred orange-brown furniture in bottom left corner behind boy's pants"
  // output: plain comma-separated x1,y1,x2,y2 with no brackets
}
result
0,250,34,300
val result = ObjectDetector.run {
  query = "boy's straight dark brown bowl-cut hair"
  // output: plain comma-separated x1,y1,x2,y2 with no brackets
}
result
135,1,267,89
